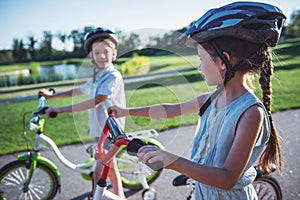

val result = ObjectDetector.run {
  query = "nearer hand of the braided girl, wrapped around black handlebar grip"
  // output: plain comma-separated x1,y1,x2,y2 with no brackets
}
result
137,145,179,169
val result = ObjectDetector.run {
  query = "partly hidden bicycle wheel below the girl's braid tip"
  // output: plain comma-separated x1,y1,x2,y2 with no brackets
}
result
253,176,282,200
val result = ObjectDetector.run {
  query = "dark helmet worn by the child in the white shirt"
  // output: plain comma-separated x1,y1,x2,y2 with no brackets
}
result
84,27,119,53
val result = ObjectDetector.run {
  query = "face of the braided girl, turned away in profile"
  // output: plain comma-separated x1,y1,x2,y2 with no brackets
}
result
197,44,224,86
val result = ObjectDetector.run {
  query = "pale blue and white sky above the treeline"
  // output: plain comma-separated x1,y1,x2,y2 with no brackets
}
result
0,0,300,49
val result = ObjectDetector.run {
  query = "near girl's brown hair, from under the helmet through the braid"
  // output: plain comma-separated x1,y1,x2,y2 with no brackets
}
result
200,36,282,174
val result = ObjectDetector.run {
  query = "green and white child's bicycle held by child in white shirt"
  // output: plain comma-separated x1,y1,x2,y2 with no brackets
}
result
0,91,163,200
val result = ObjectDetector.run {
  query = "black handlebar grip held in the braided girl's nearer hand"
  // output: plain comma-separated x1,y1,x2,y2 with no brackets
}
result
127,138,164,171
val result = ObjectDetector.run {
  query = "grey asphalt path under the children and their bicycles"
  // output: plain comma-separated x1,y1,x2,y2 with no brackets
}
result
0,109,300,200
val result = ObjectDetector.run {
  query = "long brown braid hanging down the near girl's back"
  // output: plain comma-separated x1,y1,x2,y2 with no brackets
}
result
257,48,282,174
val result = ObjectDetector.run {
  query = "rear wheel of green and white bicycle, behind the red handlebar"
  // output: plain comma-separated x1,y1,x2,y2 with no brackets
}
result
116,142,162,190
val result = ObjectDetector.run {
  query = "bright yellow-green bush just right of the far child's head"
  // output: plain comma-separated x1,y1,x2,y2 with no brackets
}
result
120,54,150,76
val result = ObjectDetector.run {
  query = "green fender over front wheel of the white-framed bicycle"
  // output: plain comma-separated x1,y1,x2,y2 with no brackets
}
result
18,154,61,187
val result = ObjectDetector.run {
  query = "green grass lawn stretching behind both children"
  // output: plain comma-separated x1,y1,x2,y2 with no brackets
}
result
0,39,300,155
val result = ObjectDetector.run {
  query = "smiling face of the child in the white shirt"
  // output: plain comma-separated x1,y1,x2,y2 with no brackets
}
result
91,41,116,69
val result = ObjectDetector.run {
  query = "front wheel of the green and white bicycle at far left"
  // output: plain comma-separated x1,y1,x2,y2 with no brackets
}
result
0,160,59,200
